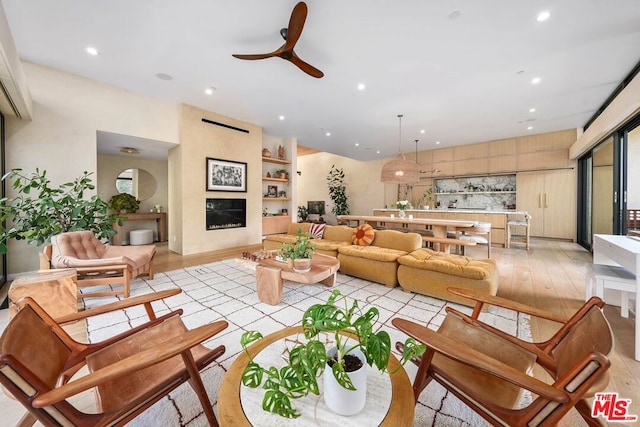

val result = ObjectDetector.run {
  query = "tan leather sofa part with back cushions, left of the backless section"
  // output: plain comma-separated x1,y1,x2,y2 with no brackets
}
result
263,223,422,287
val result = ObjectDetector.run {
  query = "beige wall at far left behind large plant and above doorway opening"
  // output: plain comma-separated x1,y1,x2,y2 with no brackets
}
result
6,62,179,275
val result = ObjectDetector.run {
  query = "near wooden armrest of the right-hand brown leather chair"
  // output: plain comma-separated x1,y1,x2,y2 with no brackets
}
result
391,318,568,403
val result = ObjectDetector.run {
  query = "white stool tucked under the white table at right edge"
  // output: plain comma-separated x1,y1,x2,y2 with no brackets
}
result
585,264,638,318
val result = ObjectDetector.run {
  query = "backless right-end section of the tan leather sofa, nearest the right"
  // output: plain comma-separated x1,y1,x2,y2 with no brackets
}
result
398,248,499,306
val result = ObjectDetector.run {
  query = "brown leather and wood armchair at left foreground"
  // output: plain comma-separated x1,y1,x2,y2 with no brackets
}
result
0,290,227,426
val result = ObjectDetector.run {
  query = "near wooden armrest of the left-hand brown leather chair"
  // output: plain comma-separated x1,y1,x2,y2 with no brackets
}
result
33,320,228,408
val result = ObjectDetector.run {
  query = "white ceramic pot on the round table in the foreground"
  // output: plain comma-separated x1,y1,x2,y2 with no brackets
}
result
323,347,367,416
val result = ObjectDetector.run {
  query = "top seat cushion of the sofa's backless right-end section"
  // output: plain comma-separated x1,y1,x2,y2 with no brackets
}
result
398,248,496,280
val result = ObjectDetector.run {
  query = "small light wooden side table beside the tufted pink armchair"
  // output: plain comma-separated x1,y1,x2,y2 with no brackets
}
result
9,269,78,319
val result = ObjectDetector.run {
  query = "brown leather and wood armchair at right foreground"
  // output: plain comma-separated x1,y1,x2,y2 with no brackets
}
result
392,289,613,426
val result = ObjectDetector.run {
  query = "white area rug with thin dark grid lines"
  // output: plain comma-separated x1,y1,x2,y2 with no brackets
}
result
85,260,531,427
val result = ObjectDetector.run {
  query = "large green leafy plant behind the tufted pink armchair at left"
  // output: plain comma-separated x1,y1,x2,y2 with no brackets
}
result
0,168,122,253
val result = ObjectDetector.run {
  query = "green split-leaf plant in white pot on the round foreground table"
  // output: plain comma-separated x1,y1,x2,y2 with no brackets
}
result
240,289,426,418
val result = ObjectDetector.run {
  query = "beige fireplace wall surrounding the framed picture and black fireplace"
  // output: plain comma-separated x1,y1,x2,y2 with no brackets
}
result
169,104,262,255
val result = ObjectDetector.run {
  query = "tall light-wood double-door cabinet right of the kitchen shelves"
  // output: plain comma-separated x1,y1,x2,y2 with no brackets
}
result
516,169,577,241
